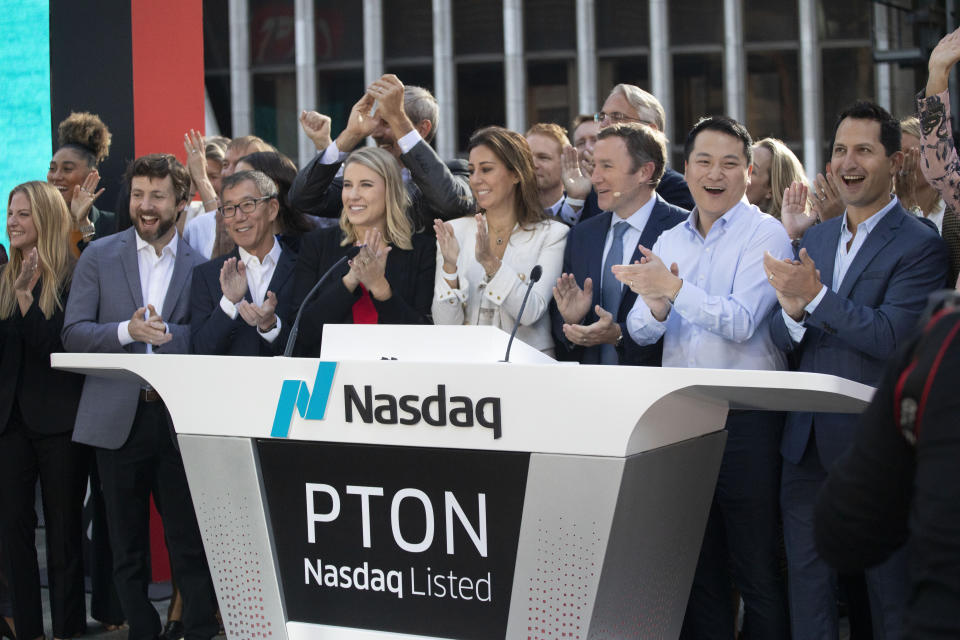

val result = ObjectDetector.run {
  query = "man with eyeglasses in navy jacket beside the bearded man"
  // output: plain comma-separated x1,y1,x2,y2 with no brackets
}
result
190,171,296,356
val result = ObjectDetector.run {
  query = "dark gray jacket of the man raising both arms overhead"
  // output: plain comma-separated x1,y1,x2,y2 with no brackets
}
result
287,141,474,235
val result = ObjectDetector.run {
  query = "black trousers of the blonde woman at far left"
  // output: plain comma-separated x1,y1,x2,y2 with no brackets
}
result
0,416,90,638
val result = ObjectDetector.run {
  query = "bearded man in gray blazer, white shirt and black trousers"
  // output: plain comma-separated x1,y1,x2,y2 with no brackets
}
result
63,154,218,640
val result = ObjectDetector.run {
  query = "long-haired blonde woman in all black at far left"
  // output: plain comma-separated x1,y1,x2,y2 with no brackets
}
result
0,182,88,639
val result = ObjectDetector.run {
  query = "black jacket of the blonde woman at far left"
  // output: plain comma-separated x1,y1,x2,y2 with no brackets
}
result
0,276,83,435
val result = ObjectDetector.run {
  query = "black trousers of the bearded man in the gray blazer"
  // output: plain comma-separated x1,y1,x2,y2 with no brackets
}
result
97,401,219,640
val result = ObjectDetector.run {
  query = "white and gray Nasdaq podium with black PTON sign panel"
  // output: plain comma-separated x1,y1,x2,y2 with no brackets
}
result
52,326,873,640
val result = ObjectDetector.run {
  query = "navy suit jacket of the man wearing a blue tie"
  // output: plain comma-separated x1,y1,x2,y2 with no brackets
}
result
550,194,690,367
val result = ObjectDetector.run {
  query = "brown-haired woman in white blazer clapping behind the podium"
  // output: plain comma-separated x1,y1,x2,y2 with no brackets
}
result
433,127,568,356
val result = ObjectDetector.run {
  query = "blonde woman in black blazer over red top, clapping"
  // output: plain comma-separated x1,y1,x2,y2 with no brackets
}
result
286,147,436,355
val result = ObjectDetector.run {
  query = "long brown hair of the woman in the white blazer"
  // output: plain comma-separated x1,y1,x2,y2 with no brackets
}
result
467,126,546,227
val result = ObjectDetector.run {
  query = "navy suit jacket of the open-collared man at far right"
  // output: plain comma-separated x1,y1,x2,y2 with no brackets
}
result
770,203,947,469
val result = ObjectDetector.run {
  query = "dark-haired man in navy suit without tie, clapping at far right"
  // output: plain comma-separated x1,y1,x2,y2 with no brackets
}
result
764,102,947,640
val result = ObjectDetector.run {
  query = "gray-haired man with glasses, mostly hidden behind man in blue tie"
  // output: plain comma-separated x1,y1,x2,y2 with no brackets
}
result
580,84,693,220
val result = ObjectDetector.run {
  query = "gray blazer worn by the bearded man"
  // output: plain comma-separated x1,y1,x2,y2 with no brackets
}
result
62,227,205,449
